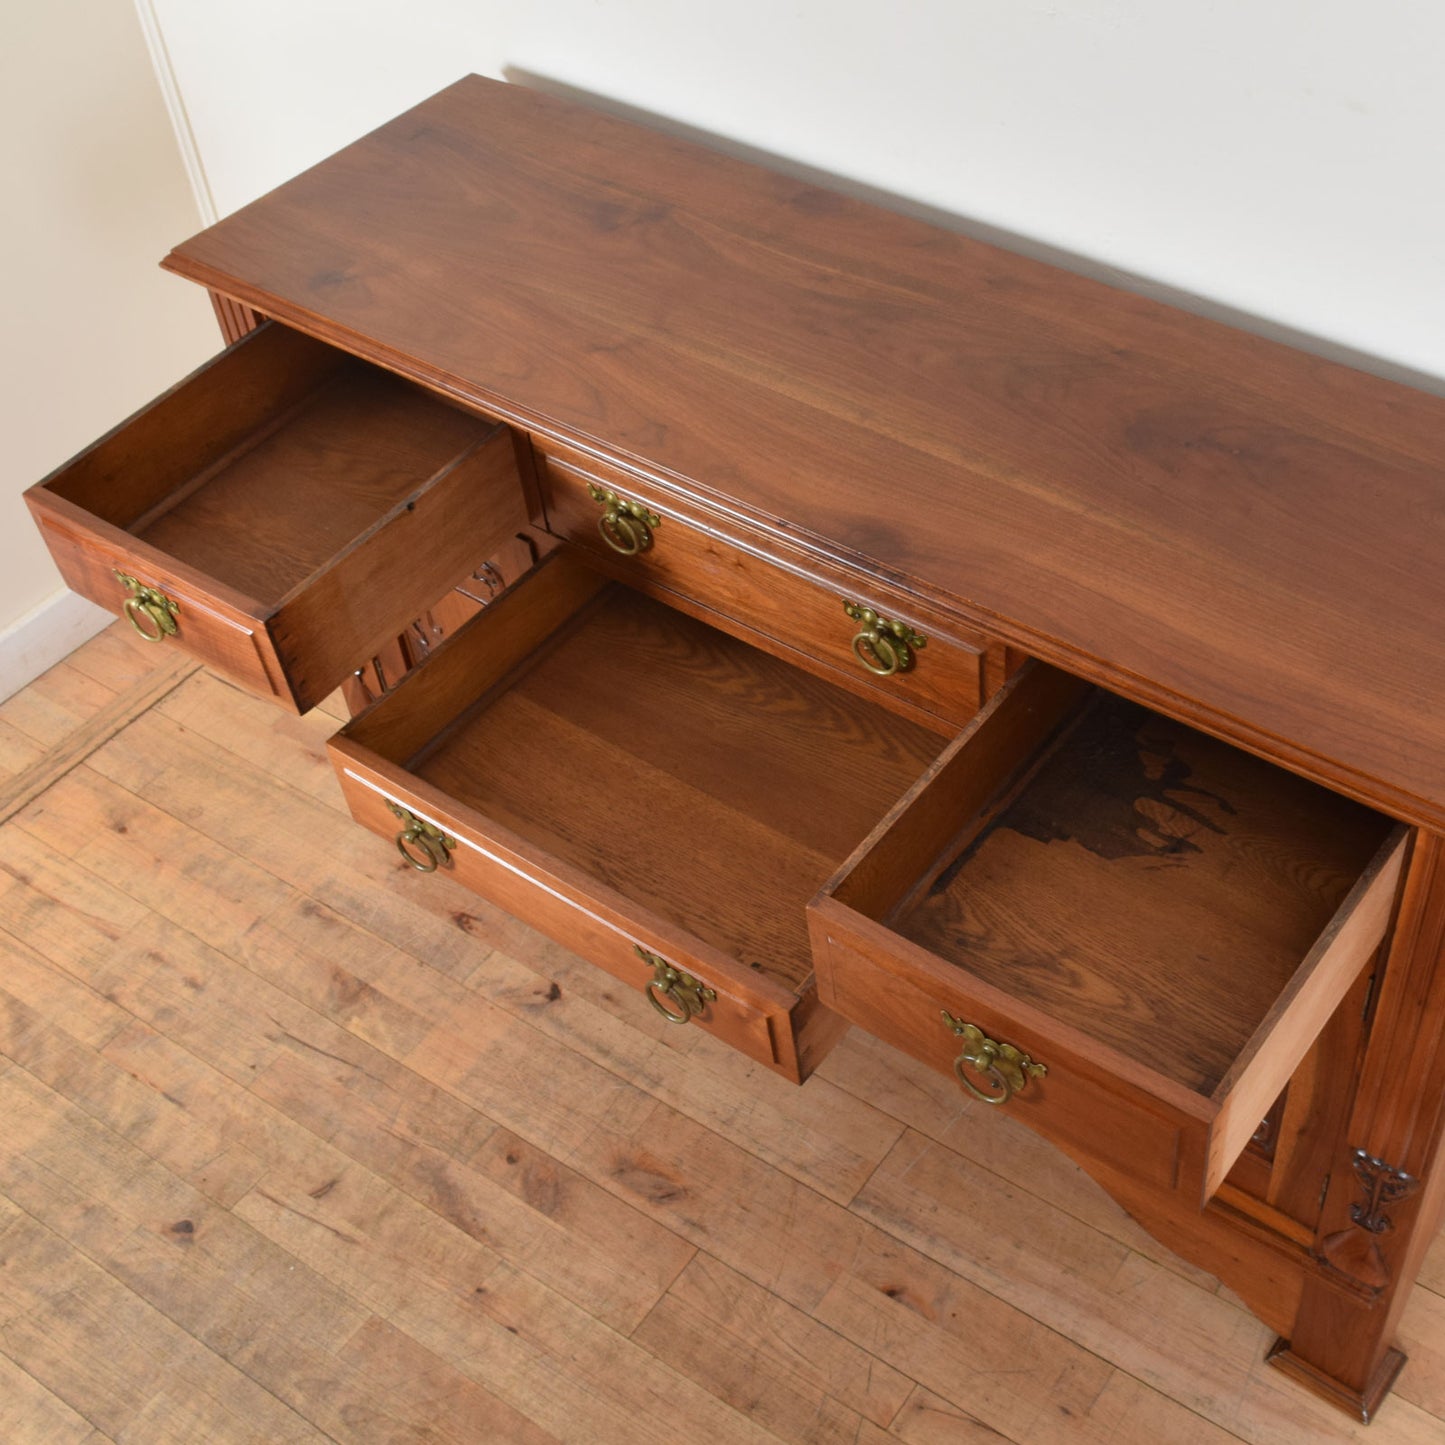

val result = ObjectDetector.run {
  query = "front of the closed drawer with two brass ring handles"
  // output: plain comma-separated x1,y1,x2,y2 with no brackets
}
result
539,444,988,725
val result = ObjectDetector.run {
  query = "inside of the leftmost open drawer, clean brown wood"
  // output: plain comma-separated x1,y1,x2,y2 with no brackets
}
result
48,325,493,605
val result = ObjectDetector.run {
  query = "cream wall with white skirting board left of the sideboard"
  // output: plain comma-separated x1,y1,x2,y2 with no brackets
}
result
0,0,218,698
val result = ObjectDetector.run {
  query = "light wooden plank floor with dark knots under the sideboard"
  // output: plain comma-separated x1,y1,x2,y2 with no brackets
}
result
0,629,1445,1445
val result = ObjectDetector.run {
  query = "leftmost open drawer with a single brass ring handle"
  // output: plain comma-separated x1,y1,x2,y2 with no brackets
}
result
26,322,527,711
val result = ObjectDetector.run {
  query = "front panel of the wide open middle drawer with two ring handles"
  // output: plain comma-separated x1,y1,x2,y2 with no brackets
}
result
332,757,808,1078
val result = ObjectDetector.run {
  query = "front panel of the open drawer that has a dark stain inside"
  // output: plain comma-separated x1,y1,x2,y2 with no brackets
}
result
812,910,1207,1192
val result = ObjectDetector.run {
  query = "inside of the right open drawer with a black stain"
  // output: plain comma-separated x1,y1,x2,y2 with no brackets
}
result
834,669,1397,1107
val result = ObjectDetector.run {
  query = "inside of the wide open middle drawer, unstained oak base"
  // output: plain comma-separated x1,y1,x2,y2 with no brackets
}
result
393,566,942,988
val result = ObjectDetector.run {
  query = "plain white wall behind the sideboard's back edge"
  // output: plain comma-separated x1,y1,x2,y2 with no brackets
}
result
149,0,1445,379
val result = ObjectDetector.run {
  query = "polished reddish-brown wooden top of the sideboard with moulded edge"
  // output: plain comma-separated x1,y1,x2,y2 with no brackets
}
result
166,77,1445,827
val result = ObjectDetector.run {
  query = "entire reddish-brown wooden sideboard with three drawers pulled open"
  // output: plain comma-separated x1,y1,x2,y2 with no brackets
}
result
29,78,1445,1418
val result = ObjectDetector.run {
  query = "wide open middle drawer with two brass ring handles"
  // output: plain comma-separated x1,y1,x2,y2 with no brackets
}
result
331,549,944,1079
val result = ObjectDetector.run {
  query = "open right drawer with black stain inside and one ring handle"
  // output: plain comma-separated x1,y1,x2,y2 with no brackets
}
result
809,663,1405,1204
